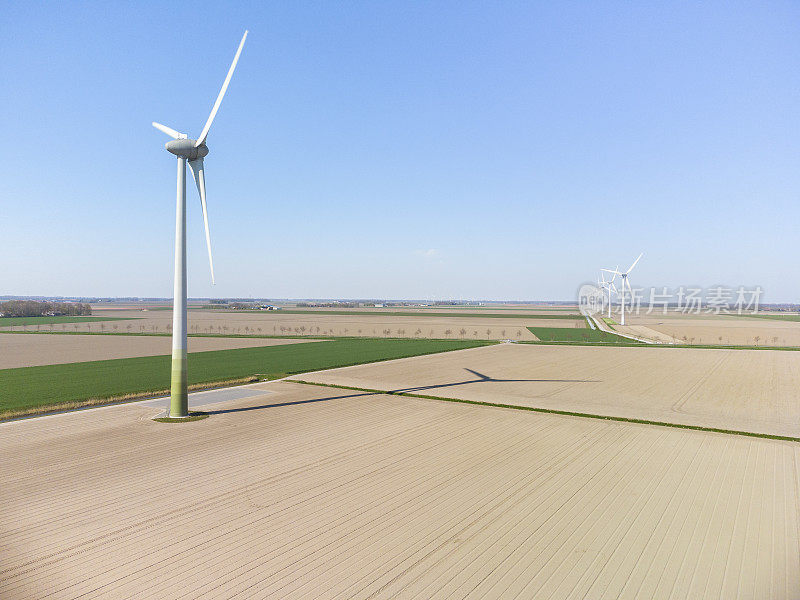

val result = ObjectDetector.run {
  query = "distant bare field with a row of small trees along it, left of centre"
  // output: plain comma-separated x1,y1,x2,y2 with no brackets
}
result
4,310,556,340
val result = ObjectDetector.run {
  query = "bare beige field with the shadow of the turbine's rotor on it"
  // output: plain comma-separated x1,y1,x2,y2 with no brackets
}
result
296,344,800,437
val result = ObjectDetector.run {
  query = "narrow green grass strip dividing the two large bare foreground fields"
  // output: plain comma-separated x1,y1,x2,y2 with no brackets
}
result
287,379,800,442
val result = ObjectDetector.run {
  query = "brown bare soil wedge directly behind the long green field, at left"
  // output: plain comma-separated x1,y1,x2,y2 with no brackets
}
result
0,333,315,369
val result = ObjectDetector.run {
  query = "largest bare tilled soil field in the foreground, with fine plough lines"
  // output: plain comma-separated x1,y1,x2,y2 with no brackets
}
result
0,382,800,600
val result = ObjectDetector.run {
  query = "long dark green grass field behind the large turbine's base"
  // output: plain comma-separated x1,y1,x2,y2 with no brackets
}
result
0,339,488,418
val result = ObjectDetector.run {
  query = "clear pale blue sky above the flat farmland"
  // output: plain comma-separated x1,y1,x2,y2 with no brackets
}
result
0,0,800,302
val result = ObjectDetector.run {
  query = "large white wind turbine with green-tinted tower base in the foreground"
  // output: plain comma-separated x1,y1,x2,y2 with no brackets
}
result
153,31,247,418
